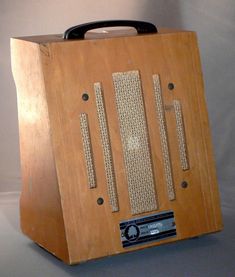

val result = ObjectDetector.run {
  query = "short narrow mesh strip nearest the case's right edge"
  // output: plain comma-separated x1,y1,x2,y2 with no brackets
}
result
173,100,189,170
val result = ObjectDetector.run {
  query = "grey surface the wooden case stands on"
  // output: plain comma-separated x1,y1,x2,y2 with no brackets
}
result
0,184,235,277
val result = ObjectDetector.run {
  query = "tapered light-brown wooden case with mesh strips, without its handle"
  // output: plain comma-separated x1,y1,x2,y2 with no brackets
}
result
11,27,222,264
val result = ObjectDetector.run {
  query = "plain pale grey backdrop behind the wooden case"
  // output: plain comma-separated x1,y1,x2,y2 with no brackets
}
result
0,0,235,195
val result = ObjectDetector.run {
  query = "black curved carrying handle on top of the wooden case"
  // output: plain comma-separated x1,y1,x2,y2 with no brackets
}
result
63,20,157,39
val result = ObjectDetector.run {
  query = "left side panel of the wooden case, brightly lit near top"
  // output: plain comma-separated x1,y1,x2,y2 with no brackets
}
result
11,39,69,263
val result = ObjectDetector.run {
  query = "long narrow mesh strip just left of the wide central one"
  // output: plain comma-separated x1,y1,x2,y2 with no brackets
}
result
94,83,119,212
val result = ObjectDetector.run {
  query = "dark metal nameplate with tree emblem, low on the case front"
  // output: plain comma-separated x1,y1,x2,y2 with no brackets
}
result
120,211,176,248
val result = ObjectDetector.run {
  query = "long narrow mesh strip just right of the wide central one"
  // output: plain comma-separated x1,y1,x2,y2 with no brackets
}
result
153,74,175,200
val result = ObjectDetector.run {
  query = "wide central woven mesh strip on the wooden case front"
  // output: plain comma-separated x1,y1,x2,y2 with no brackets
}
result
113,71,157,214
